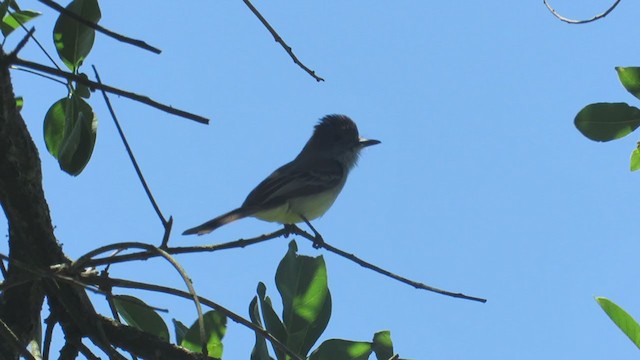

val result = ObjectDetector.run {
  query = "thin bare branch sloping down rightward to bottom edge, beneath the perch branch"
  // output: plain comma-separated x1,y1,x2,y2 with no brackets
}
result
87,276,302,359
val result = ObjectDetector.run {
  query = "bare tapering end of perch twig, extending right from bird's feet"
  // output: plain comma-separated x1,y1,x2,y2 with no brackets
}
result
287,225,487,303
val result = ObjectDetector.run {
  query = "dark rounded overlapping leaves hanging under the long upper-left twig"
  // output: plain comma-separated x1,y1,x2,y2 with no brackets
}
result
44,95,98,175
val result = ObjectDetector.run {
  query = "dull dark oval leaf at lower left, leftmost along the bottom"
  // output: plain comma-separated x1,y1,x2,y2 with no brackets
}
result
113,295,169,342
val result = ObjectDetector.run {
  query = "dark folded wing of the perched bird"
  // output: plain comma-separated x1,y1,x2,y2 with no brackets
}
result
242,159,344,207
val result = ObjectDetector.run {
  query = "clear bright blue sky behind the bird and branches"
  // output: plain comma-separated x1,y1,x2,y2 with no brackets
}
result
0,0,640,359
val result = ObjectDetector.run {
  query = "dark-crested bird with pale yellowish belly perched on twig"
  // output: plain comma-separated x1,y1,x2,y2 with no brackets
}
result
183,114,381,239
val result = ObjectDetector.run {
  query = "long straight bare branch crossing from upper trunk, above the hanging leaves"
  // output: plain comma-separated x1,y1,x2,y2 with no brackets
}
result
4,58,209,124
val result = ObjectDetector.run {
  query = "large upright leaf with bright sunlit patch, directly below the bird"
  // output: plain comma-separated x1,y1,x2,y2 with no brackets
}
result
276,241,331,356
